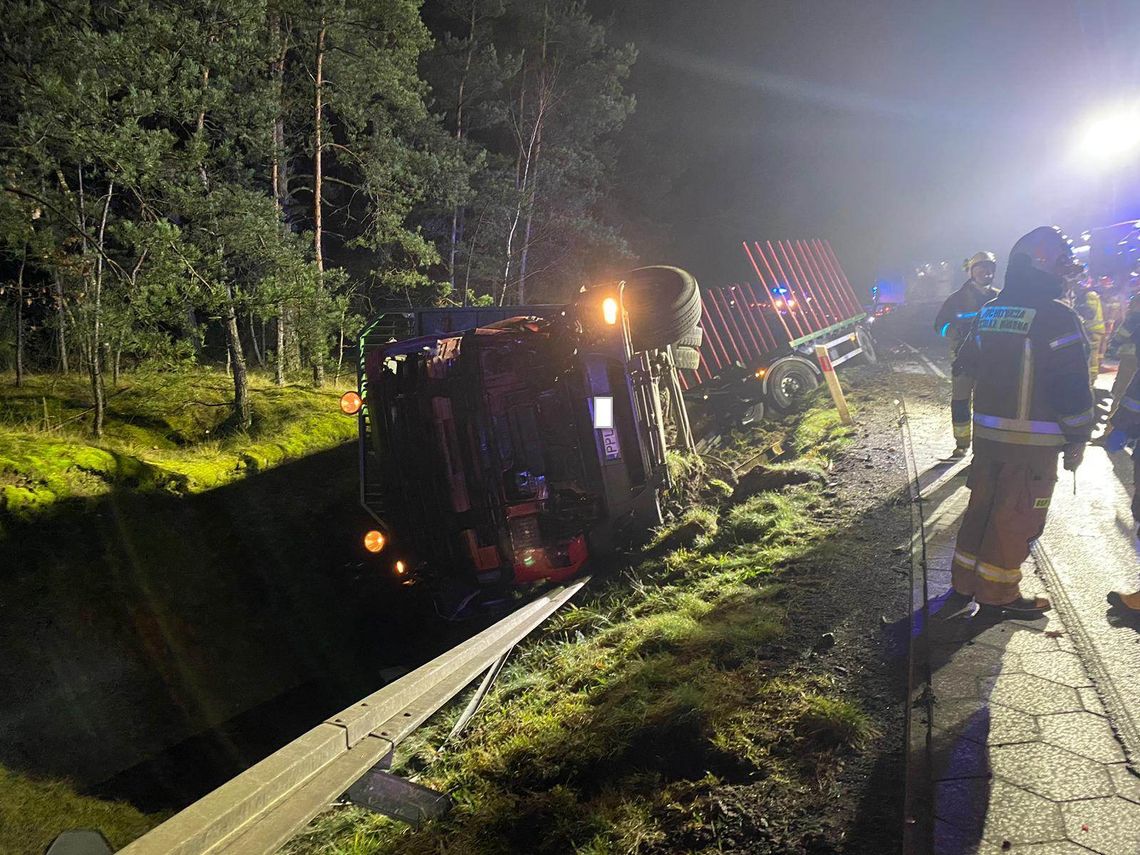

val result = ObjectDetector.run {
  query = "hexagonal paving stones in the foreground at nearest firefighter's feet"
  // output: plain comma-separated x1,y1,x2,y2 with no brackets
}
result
911,472,1140,855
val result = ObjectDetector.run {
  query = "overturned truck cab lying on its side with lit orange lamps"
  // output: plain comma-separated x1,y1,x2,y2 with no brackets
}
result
342,267,701,589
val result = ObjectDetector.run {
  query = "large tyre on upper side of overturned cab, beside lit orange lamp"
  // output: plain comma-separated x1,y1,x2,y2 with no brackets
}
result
622,266,701,350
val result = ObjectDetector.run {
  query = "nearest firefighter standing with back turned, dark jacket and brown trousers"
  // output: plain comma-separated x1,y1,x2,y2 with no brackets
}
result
952,226,1093,616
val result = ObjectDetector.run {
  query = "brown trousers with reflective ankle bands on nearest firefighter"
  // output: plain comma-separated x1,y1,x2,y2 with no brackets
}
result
952,458,1057,605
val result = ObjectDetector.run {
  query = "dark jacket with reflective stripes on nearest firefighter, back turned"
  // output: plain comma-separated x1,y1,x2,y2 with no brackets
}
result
954,276,1093,463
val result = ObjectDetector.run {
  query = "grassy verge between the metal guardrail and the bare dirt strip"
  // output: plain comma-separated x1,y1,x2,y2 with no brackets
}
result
287,394,870,855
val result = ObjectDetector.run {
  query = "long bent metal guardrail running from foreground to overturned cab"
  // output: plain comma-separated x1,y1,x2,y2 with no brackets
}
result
120,577,589,855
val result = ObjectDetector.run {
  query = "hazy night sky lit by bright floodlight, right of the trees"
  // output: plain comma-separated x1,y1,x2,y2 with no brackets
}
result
611,0,1140,288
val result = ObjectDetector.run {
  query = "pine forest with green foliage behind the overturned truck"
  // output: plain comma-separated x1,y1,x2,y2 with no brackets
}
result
0,0,636,435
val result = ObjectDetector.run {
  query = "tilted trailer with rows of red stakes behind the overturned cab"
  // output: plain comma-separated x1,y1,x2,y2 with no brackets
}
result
681,239,876,421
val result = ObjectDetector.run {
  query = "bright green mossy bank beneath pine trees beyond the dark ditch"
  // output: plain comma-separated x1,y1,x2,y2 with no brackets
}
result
0,369,356,534
